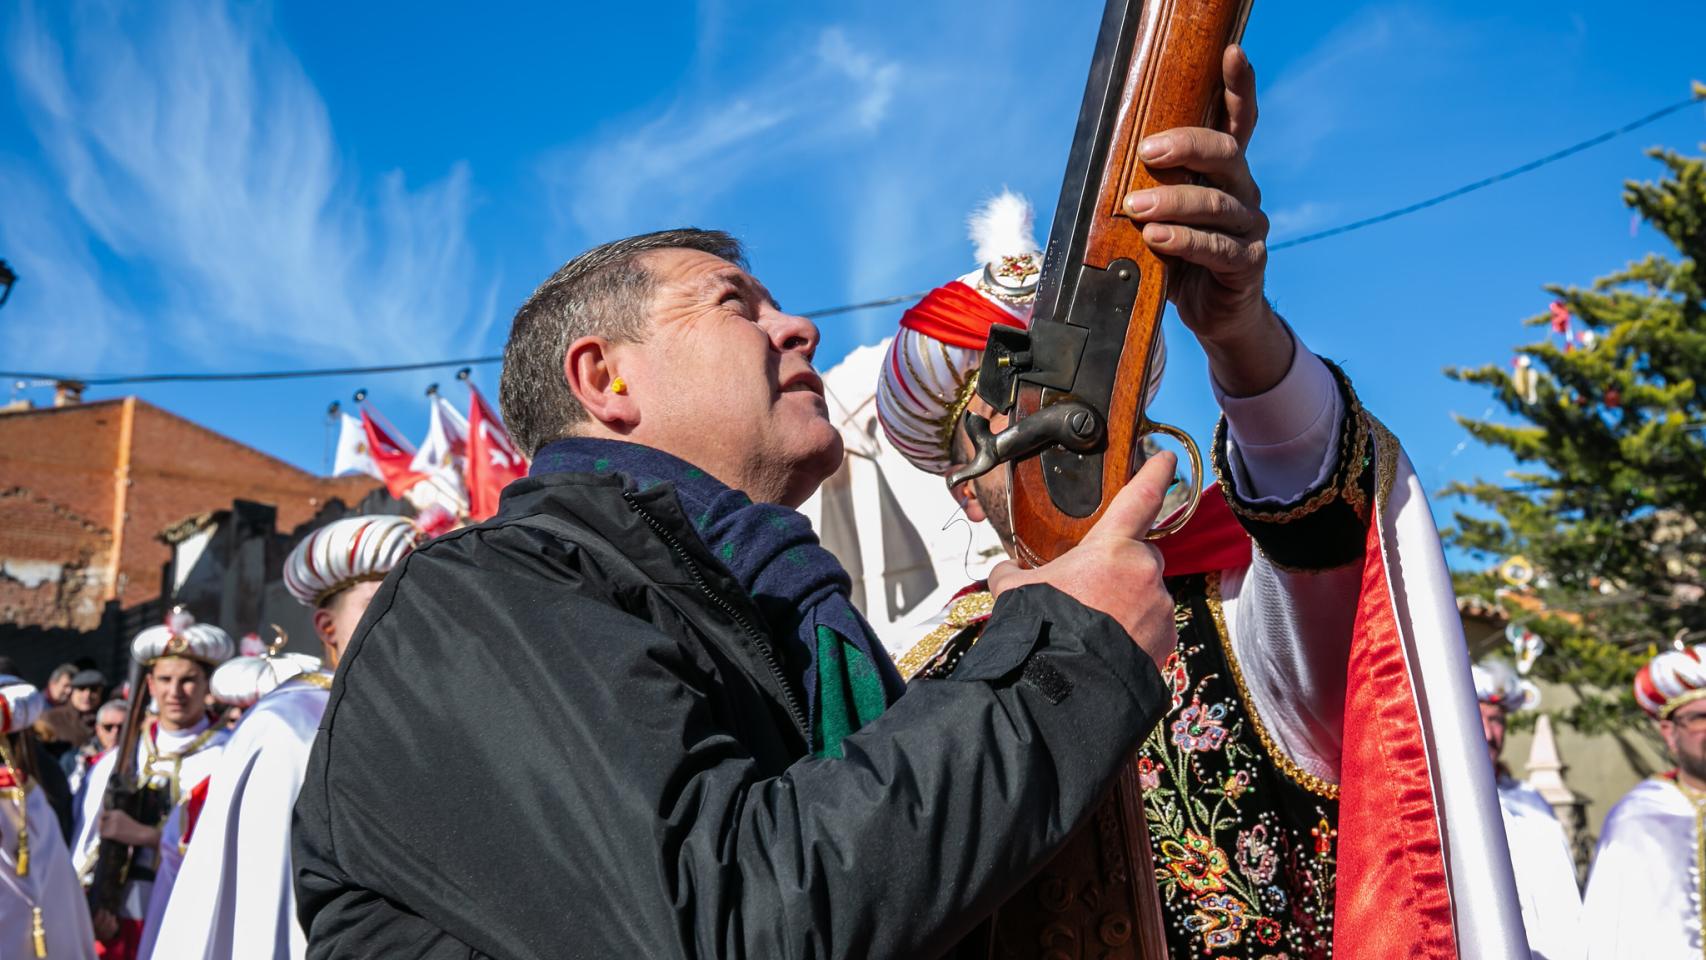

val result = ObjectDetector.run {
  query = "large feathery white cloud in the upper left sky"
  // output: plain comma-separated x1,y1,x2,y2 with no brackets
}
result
5,0,491,368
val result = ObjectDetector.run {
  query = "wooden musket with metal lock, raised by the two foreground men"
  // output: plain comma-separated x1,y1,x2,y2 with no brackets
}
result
950,0,1250,960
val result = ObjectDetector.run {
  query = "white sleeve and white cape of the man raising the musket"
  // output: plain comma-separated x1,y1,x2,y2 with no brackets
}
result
1215,343,1530,960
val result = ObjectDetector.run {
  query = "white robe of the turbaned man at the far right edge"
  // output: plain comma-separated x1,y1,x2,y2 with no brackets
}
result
1581,778,1706,960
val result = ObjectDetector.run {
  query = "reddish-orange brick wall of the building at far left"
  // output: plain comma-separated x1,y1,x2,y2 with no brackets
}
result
0,399,380,629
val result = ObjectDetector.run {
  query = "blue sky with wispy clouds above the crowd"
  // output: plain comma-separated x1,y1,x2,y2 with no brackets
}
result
0,0,1706,559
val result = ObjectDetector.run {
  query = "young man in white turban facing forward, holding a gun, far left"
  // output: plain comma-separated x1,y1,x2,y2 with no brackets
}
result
72,607,237,960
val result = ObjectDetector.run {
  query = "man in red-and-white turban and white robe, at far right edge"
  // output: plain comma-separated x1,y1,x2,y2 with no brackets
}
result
1581,646,1706,960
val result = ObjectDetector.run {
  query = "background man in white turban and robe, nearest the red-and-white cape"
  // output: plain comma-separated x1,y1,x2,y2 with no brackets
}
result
1471,660,1581,960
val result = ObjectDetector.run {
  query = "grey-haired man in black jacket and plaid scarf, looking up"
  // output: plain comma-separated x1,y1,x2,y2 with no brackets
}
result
293,230,1174,958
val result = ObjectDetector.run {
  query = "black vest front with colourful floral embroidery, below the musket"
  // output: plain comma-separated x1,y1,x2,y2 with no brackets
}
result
1138,580,1338,960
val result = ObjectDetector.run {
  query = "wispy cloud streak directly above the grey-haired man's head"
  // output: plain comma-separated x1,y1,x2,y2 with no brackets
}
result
541,27,901,239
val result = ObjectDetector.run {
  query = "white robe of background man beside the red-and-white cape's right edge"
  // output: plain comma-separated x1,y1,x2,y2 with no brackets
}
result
1498,778,1583,960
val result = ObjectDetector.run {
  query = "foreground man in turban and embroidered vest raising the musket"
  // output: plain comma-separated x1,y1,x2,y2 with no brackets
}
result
877,49,1529,958
